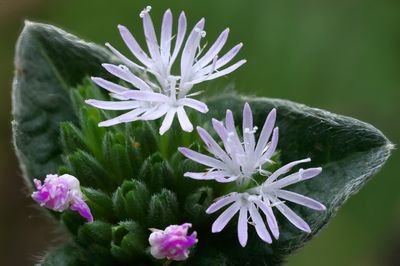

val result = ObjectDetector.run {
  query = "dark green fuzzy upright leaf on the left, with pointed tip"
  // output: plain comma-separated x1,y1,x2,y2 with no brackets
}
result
12,21,115,187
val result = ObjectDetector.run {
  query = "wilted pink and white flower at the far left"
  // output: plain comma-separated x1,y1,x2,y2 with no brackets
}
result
32,174,93,222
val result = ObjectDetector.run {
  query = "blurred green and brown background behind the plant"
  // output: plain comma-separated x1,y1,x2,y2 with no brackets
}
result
0,0,400,266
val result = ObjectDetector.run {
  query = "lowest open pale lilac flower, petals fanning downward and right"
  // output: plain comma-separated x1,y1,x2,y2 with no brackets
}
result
206,159,326,247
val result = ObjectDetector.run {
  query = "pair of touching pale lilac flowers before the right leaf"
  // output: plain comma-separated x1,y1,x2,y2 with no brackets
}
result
179,103,325,247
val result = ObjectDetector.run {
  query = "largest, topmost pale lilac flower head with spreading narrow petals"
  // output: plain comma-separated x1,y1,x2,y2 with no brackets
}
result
86,7,246,134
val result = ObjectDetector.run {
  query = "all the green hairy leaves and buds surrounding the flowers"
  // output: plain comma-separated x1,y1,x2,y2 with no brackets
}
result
10,24,392,265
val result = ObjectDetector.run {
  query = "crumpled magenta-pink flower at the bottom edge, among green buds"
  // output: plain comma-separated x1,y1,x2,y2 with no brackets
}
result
149,223,198,261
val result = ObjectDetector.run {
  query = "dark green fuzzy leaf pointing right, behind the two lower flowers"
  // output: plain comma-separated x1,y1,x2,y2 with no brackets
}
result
199,96,394,265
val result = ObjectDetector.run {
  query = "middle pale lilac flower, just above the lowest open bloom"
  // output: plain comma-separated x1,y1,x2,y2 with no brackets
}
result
179,103,278,184
